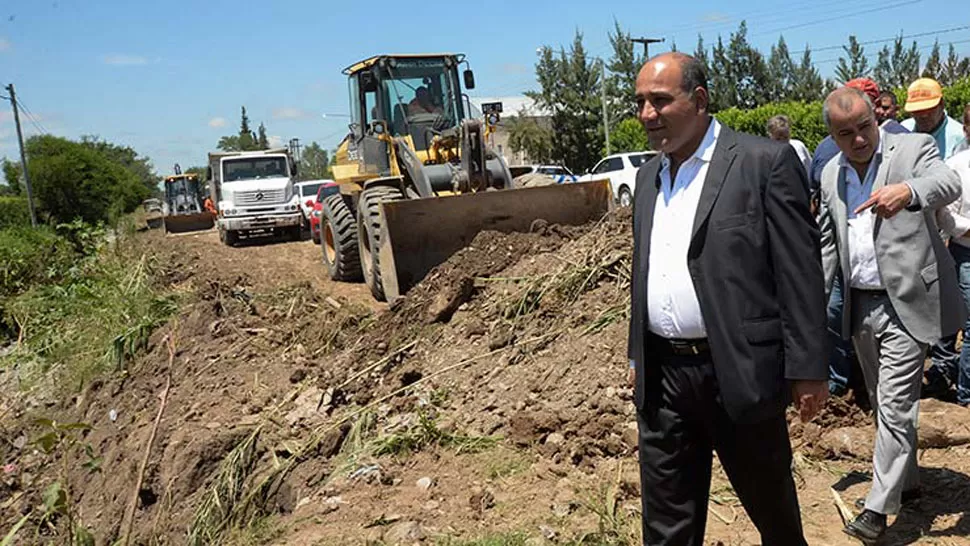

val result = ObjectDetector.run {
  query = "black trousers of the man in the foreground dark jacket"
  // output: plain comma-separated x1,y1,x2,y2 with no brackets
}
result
638,348,806,546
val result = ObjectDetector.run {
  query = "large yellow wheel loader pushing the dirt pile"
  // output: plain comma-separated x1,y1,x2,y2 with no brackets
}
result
321,53,613,300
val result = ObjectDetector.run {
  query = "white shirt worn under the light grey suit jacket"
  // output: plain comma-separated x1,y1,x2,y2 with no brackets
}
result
839,130,884,290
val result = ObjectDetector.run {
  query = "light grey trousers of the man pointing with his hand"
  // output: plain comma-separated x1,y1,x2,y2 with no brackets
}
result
852,290,928,514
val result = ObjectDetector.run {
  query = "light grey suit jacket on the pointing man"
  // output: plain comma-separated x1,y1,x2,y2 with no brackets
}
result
819,133,966,343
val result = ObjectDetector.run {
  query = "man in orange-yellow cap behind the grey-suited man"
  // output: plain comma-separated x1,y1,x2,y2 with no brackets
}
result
902,78,963,159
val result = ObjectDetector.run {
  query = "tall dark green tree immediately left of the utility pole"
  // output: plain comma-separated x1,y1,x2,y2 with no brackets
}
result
526,32,603,172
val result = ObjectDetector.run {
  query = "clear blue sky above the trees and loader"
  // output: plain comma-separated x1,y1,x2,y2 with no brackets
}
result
0,0,970,181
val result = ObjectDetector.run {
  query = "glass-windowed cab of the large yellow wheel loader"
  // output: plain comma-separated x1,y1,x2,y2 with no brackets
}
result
345,54,474,162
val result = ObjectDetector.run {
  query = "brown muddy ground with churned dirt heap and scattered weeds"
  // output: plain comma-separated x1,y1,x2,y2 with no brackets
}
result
0,219,970,545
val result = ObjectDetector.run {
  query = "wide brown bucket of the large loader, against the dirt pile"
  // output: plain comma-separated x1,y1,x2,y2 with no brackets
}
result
379,180,613,301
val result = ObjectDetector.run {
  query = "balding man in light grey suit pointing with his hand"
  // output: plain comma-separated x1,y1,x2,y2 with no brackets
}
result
819,88,965,543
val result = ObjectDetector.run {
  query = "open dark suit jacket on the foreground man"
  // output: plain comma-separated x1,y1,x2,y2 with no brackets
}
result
629,126,828,422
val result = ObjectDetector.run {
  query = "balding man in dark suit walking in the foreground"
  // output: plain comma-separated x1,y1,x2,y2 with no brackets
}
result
629,53,828,546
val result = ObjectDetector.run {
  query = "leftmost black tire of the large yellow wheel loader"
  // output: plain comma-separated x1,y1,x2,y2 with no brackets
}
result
320,194,361,282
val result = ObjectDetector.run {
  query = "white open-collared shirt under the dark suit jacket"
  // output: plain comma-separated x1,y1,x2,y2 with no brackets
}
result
647,119,721,339
